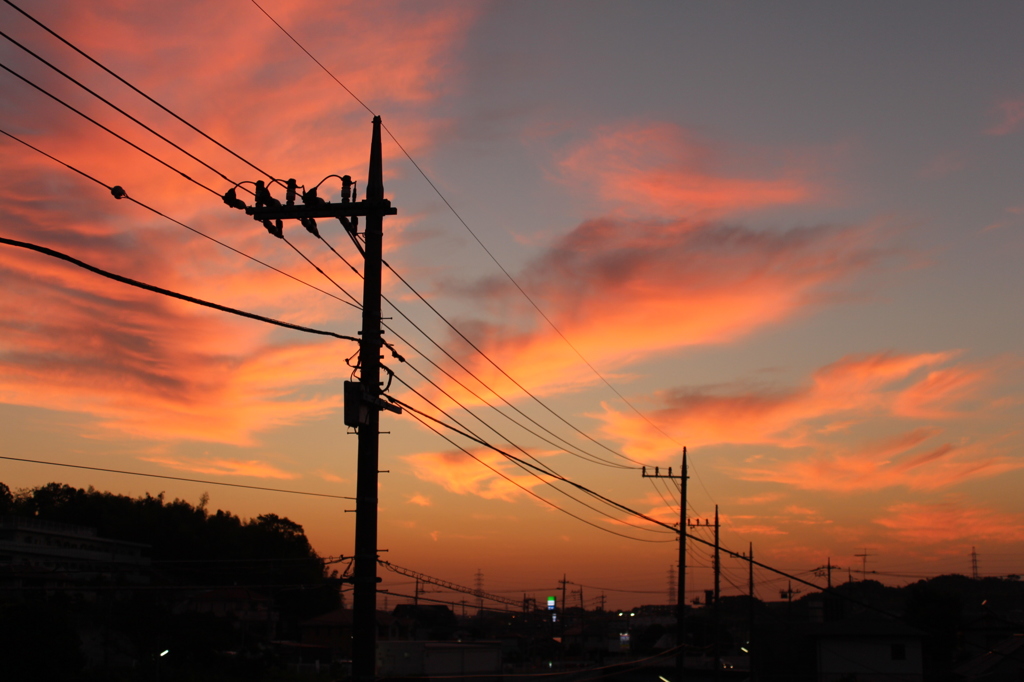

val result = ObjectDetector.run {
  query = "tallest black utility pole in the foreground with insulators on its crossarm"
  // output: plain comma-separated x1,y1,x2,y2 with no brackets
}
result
234,116,401,682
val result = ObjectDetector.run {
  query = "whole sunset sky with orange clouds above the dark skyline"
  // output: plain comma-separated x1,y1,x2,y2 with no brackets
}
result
0,0,1024,608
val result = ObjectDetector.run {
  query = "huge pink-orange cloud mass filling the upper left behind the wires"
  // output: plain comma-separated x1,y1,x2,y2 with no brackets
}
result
0,0,477,444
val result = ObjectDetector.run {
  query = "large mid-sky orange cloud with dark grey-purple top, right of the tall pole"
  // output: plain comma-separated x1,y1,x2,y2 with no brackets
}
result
419,219,878,404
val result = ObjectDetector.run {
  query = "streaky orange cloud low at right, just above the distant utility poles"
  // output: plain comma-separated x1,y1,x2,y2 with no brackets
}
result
598,352,1024,492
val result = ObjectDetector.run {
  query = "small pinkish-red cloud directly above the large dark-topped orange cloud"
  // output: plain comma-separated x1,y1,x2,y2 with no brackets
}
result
560,124,814,216
